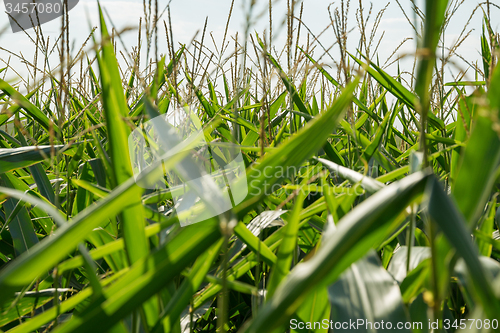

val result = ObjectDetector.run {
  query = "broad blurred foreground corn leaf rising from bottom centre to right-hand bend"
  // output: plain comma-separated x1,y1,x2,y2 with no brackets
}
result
240,172,431,332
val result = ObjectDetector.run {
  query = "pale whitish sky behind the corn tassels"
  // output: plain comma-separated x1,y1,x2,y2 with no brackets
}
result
0,0,498,89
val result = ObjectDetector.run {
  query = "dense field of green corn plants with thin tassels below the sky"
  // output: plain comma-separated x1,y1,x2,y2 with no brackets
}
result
0,0,500,333
